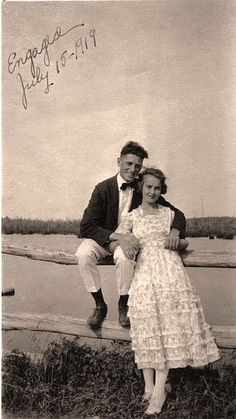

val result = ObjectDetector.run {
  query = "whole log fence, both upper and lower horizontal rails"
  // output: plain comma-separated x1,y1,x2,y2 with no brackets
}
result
2,244,236,348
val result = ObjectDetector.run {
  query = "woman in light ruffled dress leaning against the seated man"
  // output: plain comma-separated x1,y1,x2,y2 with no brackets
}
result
116,168,219,415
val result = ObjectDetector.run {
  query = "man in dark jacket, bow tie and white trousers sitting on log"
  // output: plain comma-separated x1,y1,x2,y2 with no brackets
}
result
76,141,186,330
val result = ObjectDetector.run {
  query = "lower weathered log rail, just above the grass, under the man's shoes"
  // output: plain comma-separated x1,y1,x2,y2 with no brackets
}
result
2,313,236,348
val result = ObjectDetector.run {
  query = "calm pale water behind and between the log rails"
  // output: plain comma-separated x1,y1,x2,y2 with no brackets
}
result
2,234,236,351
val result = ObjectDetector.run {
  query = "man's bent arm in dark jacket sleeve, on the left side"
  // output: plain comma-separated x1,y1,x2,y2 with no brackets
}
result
80,185,113,246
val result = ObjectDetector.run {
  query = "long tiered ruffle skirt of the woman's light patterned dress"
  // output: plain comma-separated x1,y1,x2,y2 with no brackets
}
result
128,249,219,369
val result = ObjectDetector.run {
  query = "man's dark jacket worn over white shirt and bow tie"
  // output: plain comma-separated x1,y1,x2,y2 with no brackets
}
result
80,175,186,247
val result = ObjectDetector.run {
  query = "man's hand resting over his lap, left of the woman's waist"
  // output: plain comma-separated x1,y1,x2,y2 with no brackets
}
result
109,233,139,259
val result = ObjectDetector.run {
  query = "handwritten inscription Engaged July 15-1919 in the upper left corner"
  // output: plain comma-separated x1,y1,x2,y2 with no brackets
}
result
8,23,97,109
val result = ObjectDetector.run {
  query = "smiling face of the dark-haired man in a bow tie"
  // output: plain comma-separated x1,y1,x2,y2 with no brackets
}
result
117,154,143,182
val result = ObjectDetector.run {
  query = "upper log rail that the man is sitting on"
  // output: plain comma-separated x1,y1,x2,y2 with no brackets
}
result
2,243,236,268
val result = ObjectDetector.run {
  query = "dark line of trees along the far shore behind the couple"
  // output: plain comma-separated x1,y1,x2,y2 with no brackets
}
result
2,217,236,239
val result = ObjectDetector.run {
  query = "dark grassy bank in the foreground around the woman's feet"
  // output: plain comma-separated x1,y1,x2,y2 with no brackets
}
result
2,340,235,419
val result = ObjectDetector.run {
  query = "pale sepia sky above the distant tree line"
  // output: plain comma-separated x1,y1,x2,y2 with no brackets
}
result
2,0,236,219
